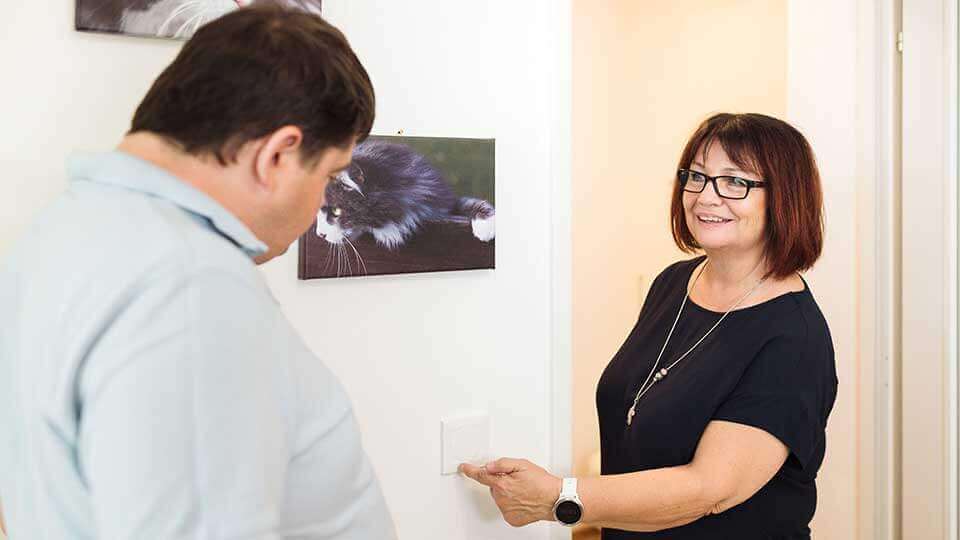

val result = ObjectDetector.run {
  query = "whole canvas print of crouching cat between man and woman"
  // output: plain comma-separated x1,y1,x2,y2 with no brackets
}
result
298,137,496,279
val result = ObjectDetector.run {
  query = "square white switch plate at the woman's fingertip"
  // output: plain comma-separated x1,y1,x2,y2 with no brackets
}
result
440,412,490,474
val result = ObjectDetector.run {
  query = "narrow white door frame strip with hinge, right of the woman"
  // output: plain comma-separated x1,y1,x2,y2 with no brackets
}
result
857,0,902,540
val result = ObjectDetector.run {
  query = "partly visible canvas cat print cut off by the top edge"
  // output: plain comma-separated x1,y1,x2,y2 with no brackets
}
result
76,0,320,39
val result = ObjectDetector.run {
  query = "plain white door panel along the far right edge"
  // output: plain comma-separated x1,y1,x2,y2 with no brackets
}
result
901,0,958,540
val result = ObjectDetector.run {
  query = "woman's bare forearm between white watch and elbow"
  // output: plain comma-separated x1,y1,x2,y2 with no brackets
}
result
577,466,720,531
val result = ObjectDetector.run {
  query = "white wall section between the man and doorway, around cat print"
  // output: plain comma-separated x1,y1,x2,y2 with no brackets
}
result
266,0,562,540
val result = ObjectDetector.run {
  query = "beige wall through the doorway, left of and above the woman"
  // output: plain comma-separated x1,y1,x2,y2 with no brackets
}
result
573,0,787,536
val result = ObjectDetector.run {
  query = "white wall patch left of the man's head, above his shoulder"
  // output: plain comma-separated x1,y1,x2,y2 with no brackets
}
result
0,7,179,253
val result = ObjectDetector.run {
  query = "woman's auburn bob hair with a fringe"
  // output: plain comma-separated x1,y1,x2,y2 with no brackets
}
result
670,113,823,278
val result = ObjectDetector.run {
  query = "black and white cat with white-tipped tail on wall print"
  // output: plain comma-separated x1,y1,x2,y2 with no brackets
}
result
316,140,496,250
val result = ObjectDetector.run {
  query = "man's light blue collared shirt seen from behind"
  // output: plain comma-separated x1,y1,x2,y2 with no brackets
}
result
0,152,395,540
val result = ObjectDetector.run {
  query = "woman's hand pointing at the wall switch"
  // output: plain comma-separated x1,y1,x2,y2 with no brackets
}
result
459,458,562,527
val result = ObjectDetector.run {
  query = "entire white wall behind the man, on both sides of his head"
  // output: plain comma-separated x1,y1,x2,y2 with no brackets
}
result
0,0,568,540
